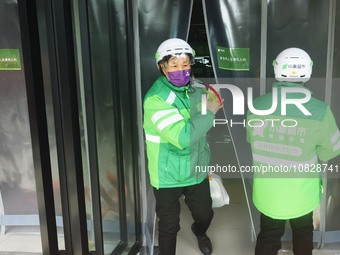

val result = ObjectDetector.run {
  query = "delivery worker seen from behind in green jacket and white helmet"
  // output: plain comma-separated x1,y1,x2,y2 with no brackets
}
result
247,48,340,255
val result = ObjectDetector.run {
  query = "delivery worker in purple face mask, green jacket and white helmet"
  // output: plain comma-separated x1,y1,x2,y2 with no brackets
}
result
144,38,222,255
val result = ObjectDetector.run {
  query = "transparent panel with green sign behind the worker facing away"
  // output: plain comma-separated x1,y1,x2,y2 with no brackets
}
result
203,0,340,247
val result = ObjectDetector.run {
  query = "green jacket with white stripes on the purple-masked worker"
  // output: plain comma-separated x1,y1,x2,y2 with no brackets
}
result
144,76,214,189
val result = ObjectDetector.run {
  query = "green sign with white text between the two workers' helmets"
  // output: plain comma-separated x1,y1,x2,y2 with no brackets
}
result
217,46,250,71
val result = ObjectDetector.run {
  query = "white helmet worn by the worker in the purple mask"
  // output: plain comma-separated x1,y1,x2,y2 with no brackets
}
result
155,38,195,66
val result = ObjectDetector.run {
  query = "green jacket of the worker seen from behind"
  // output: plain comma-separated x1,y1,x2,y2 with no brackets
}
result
247,82,340,219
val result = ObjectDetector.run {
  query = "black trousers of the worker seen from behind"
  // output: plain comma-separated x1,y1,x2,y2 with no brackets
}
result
255,212,314,255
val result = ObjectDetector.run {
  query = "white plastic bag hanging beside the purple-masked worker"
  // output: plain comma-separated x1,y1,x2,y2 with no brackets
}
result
209,173,230,208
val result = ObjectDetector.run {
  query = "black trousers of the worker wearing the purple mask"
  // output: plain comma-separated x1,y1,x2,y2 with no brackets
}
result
154,179,214,255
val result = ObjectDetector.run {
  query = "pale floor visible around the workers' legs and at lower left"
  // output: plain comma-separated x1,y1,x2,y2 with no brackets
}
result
0,179,340,255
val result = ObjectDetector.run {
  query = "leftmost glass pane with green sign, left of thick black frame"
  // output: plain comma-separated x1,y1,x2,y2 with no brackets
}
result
0,0,42,253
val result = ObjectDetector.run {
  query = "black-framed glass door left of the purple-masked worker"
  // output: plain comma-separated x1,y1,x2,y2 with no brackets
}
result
15,0,141,255
